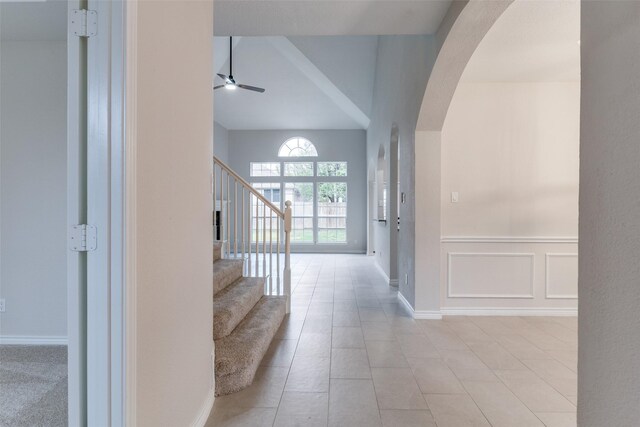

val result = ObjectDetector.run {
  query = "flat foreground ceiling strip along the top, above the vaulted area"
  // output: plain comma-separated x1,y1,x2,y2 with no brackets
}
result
214,0,451,36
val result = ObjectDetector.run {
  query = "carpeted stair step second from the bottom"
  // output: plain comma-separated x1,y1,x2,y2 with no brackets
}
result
213,277,264,340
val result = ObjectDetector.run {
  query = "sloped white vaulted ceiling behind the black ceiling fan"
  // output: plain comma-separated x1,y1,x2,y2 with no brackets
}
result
214,36,378,130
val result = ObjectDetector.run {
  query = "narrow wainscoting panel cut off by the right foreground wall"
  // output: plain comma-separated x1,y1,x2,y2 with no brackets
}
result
545,253,578,299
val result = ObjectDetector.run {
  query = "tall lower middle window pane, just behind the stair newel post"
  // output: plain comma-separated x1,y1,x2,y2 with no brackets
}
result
284,182,314,243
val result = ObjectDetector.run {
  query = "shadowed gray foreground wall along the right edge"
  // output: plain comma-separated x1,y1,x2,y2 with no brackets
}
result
578,1,640,427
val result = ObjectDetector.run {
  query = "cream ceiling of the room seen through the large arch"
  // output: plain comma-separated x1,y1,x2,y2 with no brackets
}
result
462,0,580,82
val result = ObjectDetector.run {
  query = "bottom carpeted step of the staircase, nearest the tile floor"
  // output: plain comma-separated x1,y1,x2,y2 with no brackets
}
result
215,296,286,396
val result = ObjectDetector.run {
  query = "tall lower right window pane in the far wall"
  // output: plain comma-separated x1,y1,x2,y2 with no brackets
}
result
318,182,347,243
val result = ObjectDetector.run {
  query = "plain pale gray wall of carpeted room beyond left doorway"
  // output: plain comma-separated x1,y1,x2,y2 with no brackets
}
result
0,41,67,338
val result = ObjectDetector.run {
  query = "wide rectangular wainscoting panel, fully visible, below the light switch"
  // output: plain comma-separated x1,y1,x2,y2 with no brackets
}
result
447,252,535,298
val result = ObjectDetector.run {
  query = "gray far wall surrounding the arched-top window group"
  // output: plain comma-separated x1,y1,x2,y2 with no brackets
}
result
229,130,367,253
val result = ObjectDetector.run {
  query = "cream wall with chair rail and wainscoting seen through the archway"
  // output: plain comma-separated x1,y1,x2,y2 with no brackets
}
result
440,82,580,314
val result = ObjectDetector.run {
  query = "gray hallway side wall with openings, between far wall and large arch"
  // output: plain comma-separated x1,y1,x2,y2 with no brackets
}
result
367,36,436,305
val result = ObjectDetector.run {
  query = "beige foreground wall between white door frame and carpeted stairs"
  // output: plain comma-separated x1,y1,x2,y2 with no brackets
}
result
136,0,214,427
